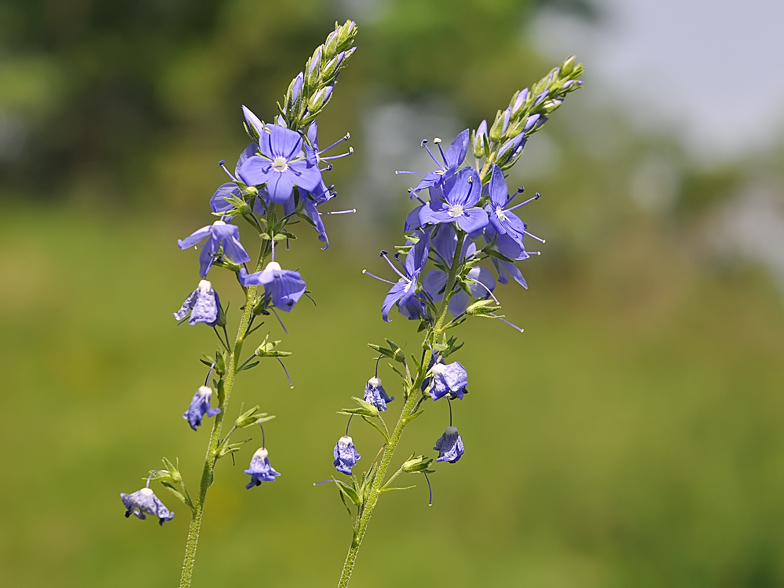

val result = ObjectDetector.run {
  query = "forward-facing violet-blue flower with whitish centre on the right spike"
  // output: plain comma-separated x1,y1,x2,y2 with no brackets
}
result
419,168,488,233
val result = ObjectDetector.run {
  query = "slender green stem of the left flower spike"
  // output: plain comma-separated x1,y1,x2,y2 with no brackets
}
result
180,241,268,588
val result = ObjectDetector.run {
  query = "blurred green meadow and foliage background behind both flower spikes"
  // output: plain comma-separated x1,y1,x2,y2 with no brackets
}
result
0,0,784,588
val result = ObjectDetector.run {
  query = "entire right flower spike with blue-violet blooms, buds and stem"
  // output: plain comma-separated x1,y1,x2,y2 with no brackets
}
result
318,57,583,588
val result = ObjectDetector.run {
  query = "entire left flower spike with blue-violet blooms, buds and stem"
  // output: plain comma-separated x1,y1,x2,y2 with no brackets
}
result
121,21,357,587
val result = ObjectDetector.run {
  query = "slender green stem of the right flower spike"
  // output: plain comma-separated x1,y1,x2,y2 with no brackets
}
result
338,232,465,588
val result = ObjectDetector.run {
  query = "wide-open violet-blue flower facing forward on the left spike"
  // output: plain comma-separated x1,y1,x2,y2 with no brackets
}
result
238,125,321,203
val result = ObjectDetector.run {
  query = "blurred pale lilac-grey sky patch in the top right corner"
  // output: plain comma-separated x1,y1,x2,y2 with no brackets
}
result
536,0,784,162
